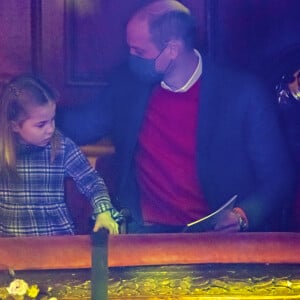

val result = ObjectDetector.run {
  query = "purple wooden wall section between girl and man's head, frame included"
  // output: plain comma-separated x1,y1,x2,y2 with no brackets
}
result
35,0,163,105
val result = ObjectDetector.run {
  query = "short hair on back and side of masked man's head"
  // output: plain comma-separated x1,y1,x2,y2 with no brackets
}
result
148,10,196,49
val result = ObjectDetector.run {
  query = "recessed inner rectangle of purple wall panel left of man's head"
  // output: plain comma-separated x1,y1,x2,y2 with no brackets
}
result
65,1,120,85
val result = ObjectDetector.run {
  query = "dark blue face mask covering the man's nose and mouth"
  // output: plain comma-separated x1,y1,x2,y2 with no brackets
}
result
129,53,163,83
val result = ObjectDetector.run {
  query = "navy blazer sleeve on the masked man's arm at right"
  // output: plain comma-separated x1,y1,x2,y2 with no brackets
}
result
239,82,294,230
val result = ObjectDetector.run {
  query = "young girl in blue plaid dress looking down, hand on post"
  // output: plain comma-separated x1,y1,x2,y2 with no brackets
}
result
0,75,120,236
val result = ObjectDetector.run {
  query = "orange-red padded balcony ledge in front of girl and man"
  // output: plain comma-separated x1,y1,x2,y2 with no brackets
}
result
0,232,300,270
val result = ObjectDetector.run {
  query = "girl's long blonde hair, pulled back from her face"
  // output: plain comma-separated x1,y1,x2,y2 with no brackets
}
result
0,75,58,180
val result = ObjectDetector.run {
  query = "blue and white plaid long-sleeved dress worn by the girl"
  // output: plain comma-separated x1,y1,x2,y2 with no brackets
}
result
0,131,120,236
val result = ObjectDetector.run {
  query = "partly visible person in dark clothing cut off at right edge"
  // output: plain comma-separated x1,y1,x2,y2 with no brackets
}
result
273,50,300,231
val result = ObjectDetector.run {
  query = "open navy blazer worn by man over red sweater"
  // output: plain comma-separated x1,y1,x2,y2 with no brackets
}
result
111,60,294,230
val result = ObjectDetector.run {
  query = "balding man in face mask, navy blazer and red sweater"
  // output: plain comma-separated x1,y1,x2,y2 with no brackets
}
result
57,0,293,233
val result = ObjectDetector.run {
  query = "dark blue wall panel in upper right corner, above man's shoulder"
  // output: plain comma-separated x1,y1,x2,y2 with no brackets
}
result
214,0,300,72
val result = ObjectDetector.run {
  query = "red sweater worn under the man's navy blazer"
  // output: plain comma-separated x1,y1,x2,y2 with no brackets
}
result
136,81,208,225
